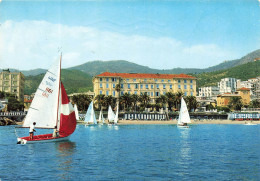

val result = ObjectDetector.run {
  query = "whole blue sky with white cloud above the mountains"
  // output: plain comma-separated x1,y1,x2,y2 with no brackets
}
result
0,0,260,70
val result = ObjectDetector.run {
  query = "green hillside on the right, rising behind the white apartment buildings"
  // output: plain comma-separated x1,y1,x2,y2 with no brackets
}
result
193,60,260,87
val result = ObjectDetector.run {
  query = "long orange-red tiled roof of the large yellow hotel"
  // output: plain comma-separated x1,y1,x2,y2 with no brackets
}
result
96,72,196,79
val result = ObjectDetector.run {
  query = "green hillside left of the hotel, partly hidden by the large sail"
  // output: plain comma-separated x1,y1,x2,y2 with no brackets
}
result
24,69,93,95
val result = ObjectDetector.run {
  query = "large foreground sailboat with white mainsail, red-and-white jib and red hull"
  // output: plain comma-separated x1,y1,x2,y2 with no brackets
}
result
17,56,77,144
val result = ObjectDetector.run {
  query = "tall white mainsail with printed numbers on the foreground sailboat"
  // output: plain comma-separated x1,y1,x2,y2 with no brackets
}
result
23,58,61,128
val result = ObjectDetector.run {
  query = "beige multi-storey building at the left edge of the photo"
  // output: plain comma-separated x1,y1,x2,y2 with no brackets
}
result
0,69,25,101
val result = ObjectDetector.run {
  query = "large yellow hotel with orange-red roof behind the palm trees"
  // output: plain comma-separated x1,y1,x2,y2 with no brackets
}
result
93,72,196,103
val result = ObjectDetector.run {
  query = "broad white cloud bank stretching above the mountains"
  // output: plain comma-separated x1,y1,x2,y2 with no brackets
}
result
0,21,234,70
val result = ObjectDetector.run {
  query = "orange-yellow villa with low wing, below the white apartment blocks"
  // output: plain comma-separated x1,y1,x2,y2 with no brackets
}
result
217,87,251,107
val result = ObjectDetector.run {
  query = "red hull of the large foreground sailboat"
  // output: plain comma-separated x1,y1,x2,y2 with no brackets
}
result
17,134,69,144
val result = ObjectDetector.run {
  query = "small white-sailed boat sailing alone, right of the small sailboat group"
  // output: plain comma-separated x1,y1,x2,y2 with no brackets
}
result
177,98,191,128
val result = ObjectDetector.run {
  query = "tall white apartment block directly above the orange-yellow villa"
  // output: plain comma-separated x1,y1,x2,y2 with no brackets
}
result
218,78,237,94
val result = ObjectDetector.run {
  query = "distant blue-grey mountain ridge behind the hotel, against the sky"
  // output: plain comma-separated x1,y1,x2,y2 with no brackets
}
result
69,49,260,76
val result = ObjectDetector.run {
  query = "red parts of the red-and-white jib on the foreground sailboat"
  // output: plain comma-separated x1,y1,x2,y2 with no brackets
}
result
59,83,77,137
